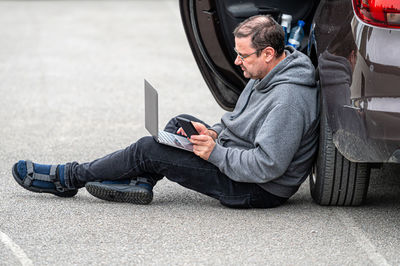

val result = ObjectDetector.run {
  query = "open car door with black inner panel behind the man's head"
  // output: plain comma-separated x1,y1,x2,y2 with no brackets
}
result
179,0,319,110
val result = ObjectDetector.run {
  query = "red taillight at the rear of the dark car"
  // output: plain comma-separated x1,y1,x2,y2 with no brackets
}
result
353,0,400,29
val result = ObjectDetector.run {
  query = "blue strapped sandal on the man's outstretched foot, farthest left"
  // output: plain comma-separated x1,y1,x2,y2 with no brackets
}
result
12,160,78,198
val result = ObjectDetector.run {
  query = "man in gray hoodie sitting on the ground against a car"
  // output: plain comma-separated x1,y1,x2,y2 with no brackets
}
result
13,16,318,208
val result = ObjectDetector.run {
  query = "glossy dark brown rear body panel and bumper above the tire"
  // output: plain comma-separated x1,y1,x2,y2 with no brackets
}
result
309,0,400,163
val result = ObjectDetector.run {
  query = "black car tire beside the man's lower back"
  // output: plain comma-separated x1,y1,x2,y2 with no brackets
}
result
310,108,370,206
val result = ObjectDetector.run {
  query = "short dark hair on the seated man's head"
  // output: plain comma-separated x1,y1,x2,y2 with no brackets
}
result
233,15,285,57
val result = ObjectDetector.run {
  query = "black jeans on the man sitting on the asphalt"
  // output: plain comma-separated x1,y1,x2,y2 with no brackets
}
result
66,115,287,208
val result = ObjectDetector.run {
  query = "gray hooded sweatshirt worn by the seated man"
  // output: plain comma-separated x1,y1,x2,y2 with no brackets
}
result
208,47,318,198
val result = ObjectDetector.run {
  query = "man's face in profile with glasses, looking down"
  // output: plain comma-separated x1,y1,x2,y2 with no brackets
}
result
235,36,268,79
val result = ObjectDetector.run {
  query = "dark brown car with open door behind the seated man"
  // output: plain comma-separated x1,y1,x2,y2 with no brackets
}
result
180,0,400,206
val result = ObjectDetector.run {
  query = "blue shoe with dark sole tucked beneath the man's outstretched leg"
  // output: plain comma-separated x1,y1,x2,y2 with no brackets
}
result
85,178,153,204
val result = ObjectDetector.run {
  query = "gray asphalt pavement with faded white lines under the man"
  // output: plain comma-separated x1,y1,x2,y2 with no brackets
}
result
0,1,400,265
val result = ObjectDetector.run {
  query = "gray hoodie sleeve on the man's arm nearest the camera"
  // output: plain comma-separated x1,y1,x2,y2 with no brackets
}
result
208,104,305,183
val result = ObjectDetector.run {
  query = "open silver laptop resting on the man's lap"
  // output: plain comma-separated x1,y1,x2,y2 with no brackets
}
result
144,80,193,152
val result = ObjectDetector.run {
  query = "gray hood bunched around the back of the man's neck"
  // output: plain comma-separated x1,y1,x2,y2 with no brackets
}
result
255,46,315,92
